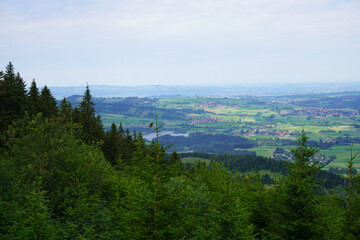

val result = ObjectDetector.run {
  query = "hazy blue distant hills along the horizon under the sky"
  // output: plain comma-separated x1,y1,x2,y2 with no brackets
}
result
51,82,360,99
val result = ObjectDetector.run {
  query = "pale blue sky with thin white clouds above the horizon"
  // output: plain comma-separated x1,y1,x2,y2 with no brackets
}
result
0,0,360,87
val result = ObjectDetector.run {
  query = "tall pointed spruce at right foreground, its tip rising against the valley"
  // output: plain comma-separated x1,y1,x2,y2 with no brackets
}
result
276,131,319,239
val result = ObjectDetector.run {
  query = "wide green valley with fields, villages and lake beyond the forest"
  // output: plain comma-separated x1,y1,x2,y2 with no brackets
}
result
66,92,360,173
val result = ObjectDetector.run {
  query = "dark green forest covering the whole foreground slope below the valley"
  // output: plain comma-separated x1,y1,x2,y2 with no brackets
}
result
0,63,360,240
